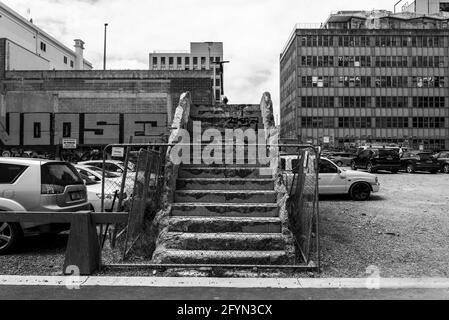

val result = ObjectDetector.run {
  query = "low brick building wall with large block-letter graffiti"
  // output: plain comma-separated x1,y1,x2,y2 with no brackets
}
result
0,70,212,155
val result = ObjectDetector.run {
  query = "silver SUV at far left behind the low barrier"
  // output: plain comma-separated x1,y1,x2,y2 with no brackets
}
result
0,158,90,254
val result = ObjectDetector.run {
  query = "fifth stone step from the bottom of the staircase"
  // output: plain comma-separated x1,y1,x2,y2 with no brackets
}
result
175,190,277,203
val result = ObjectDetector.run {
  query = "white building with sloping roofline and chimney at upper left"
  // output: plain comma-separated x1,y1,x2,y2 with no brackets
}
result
0,2,92,71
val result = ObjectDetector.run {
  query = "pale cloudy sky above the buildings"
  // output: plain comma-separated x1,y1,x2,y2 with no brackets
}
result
0,0,396,115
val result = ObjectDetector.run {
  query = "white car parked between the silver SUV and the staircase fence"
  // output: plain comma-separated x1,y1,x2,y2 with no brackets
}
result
75,165,133,212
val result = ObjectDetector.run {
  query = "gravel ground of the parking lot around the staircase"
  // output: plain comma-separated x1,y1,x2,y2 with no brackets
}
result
0,173,449,277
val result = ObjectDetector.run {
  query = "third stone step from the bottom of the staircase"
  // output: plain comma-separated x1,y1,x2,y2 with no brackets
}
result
168,216,282,233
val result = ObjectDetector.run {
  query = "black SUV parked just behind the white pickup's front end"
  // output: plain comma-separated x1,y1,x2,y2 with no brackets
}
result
351,148,401,173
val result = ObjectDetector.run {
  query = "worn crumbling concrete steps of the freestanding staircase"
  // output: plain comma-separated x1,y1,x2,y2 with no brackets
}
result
153,106,294,265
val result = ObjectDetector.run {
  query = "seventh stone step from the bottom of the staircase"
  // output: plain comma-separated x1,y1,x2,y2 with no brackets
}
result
178,164,272,179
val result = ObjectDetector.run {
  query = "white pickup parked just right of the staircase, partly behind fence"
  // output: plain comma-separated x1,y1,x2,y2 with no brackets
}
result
281,155,380,201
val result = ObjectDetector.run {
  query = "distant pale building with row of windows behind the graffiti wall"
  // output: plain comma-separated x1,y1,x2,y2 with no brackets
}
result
150,42,223,101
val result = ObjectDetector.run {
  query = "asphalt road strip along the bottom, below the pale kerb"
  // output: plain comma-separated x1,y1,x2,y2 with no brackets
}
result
0,286,449,301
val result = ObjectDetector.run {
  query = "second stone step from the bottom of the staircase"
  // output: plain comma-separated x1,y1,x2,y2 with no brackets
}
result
158,232,287,251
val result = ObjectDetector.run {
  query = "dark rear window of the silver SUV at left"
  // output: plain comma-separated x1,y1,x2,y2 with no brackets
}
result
41,163,84,187
